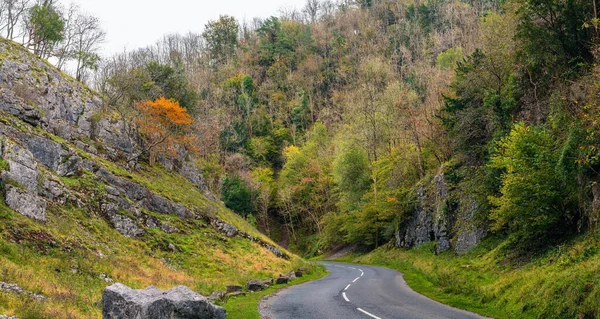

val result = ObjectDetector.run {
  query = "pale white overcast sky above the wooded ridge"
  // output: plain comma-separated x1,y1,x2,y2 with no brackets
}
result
61,0,306,55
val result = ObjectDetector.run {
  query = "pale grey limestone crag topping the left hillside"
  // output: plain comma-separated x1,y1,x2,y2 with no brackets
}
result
0,40,138,157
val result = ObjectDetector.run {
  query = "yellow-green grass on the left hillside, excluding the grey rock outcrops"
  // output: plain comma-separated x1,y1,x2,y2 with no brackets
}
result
0,126,324,318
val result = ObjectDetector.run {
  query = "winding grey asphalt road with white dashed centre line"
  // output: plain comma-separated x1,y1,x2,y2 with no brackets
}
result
259,262,485,319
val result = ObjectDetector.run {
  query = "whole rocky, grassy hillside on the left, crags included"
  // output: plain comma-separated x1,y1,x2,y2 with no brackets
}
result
0,39,310,318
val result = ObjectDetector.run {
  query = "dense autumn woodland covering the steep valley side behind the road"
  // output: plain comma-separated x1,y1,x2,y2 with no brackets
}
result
5,0,600,255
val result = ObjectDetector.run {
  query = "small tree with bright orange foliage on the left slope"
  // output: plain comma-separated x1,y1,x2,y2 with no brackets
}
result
135,97,195,165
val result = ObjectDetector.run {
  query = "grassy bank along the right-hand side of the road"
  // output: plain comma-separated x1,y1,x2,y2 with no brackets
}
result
336,235,600,318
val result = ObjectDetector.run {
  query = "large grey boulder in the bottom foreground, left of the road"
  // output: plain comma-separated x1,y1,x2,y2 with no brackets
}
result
102,283,226,319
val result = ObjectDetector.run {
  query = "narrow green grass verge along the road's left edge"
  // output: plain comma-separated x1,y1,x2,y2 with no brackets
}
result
220,265,327,319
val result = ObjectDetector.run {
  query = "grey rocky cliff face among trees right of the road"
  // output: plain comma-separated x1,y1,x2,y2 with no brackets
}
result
395,174,486,254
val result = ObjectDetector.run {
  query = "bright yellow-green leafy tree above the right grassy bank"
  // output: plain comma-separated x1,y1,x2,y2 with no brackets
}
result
489,123,576,245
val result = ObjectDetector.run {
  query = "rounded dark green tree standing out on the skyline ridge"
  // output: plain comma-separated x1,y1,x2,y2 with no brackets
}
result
202,16,240,67
